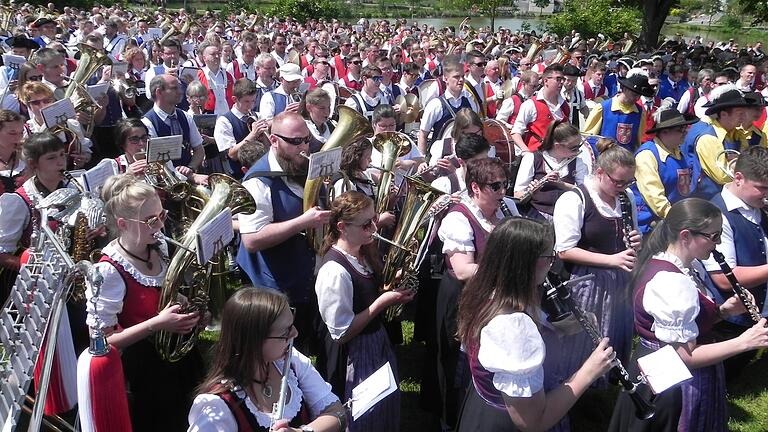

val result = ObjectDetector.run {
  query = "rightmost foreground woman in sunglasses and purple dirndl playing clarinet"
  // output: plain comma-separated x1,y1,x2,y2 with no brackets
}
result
610,198,768,432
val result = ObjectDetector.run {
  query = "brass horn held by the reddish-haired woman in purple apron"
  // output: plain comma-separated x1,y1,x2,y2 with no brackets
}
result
375,176,444,320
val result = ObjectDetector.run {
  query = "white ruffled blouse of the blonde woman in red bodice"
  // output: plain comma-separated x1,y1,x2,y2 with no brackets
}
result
85,240,168,328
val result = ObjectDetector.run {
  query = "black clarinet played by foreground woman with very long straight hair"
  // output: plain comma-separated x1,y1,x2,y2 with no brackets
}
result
547,275,656,420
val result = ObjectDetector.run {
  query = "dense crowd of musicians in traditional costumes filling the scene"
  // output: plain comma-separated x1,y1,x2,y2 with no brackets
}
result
0,5,768,432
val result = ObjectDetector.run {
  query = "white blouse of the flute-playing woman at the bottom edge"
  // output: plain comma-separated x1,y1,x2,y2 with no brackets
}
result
187,348,339,432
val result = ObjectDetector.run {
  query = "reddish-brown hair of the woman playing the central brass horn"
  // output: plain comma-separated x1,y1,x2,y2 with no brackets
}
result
320,191,382,275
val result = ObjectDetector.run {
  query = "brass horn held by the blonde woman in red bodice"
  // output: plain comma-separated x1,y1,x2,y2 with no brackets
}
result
155,174,256,362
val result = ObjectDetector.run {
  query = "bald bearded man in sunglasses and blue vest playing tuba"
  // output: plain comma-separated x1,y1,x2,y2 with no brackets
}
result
237,112,331,352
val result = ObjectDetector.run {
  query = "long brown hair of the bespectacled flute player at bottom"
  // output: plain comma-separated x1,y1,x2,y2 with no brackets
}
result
198,287,289,394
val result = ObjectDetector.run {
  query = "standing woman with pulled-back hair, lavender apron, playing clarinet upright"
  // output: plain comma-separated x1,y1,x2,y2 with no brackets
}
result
553,141,641,386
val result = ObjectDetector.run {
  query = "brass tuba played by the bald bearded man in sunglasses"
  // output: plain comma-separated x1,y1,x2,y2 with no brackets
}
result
304,105,373,251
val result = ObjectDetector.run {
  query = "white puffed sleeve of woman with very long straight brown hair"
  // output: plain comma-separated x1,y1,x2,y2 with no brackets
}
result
477,312,547,397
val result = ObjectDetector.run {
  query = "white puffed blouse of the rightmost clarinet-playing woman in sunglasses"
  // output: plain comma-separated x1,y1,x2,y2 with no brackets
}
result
643,252,701,343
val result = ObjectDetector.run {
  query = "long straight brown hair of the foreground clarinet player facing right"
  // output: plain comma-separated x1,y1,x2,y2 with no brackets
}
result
457,218,555,346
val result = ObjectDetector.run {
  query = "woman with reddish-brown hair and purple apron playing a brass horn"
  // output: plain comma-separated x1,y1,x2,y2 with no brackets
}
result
315,191,413,432
